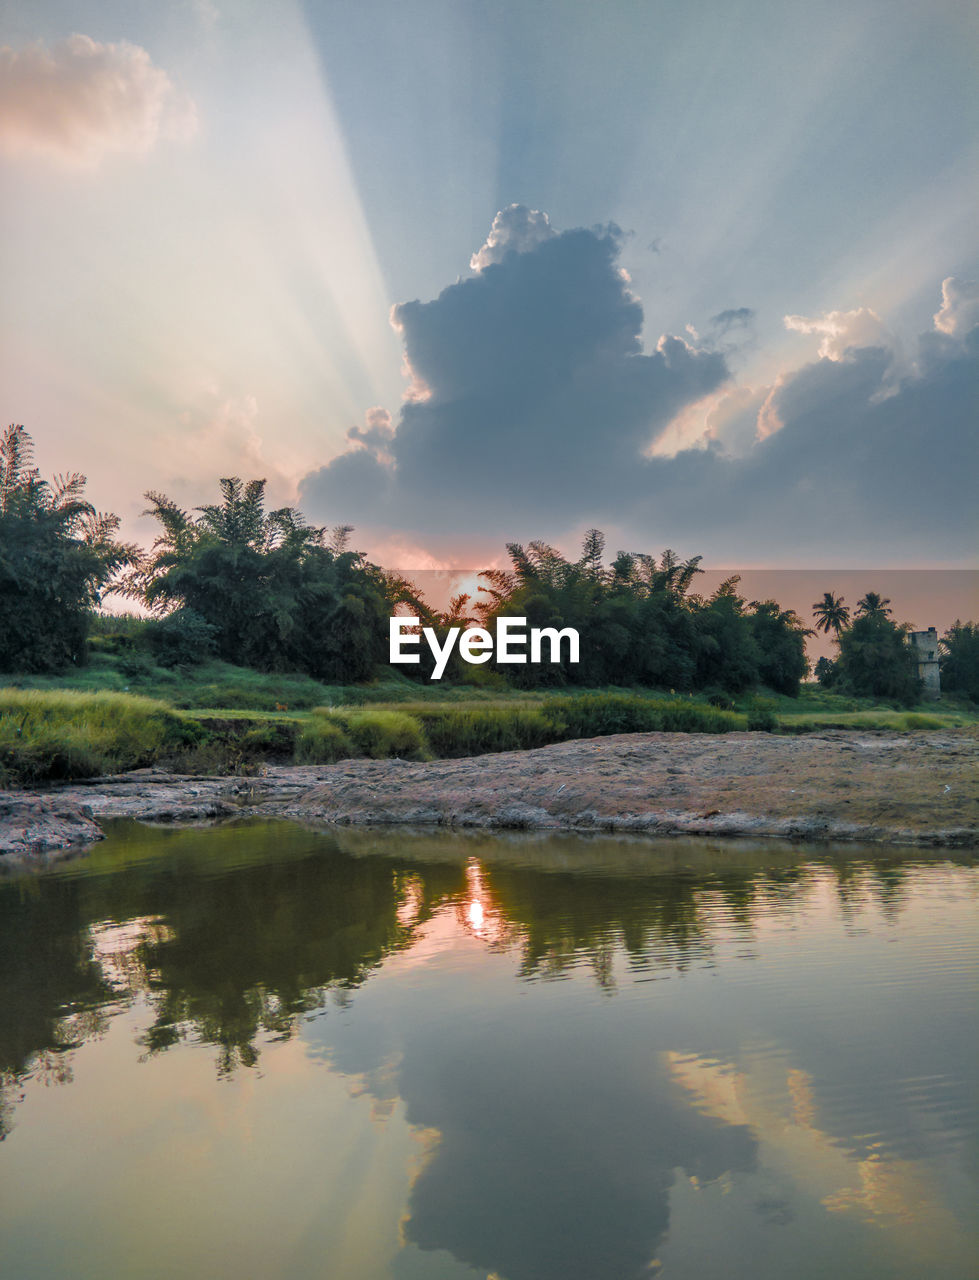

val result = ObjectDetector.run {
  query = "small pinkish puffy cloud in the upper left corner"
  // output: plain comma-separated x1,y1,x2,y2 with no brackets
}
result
0,35,197,168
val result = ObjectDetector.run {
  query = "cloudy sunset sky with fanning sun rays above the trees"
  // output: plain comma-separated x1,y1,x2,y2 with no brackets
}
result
0,0,979,609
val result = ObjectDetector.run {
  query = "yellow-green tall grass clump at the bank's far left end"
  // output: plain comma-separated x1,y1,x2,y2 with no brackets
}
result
0,689,202,785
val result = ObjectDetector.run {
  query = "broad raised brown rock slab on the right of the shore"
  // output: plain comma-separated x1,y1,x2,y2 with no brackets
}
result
283,731,979,846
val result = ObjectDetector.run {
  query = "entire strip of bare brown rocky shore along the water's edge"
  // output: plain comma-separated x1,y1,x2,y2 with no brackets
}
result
0,730,979,861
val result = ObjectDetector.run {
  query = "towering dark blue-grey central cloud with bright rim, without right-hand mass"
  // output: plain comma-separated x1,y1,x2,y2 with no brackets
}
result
302,207,727,530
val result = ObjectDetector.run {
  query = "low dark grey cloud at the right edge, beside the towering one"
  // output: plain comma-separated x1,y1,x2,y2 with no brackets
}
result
648,328,979,562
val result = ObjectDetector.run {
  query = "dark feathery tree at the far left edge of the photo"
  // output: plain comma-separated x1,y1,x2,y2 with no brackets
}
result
0,425,138,672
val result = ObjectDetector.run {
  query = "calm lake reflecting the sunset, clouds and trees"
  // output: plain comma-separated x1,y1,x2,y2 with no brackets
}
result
0,822,979,1280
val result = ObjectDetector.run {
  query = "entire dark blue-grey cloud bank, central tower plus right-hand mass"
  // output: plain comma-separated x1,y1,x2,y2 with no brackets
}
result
302,210,979,563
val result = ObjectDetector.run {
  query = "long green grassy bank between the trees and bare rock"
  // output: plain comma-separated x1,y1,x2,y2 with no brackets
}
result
0,650,979,786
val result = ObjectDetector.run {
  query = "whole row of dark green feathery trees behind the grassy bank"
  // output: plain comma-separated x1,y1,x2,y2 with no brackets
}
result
0,426,979,703
